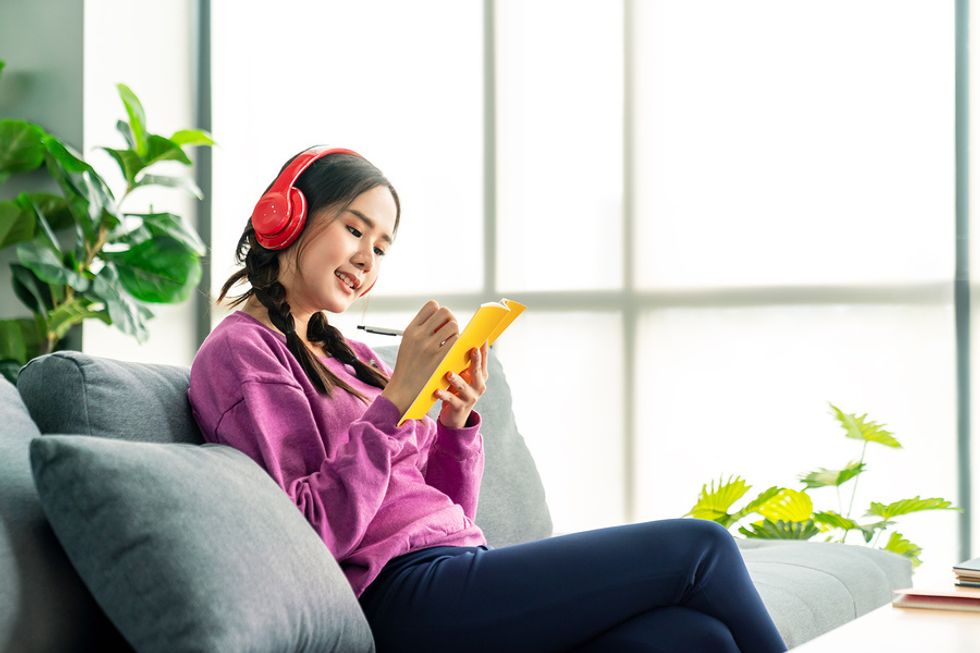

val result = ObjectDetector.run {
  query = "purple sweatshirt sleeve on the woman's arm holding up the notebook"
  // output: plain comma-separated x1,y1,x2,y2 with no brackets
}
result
421,410,484,521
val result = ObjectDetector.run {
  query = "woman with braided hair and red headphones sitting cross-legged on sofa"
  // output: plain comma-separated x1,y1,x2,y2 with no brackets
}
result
188,148,786,653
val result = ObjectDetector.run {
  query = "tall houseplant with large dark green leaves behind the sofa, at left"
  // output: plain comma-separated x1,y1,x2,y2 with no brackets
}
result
0,61,214,381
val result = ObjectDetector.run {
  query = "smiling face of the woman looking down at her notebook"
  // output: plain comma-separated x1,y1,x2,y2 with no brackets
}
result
282,186,397,313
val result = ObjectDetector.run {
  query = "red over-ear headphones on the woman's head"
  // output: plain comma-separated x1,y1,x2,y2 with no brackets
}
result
251,146,377,297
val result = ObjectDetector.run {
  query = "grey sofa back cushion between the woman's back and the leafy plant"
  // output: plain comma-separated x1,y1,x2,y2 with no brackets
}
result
17,351,204,444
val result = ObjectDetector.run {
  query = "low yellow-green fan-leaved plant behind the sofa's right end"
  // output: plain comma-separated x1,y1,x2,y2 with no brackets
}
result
682,404,962,567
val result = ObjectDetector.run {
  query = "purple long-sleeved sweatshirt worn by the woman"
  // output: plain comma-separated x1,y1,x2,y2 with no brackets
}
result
187,311,487,598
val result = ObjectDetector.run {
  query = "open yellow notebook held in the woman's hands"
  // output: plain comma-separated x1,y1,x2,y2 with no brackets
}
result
398,298,527,426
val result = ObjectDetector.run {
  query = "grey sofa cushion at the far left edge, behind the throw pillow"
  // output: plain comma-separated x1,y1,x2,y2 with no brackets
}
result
0,377,131,653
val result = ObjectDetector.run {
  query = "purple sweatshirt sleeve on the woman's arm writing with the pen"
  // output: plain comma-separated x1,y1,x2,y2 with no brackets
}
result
216,380,415,561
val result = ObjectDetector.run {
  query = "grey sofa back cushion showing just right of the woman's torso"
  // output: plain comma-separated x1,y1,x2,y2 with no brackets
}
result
373,345,553,547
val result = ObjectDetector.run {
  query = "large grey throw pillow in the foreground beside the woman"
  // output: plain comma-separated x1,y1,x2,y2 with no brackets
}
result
30,435,375,653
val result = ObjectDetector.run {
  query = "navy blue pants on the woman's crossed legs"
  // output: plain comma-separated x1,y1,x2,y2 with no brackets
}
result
359,518,786,653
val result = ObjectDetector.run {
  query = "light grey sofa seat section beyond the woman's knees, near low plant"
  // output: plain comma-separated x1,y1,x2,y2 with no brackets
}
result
735,538,912,648
